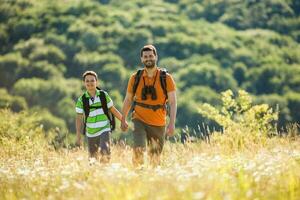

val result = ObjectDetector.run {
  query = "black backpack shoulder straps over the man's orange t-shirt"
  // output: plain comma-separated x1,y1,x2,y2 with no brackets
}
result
133,68,168,100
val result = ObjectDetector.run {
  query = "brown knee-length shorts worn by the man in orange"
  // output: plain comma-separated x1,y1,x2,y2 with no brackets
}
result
132,119,166,154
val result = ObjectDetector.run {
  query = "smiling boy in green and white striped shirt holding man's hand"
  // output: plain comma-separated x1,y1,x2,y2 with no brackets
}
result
76,71,123,163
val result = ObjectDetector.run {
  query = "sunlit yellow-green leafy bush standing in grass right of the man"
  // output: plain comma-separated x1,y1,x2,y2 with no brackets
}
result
199,90,278,149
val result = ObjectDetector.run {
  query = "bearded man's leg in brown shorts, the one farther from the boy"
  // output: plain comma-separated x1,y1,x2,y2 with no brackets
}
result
146,125,166,167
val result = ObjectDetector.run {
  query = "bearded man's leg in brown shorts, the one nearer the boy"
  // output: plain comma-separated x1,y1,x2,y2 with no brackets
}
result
132,119,146,167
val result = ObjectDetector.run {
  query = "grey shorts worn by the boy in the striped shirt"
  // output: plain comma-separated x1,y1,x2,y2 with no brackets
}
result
87,131,110,157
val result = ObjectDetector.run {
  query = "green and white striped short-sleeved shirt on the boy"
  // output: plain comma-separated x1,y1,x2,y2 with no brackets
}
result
76,90,113,137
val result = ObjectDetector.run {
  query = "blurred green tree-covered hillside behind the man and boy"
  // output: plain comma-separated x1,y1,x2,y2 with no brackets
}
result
0,0,300,140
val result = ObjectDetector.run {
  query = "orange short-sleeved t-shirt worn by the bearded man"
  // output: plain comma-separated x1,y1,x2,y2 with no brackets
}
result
127,68,176,126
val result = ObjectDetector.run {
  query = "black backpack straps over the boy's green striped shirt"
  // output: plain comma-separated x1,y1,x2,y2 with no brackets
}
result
81,87,116,135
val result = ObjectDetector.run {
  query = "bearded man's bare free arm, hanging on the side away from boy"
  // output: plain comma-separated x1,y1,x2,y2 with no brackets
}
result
167,91,177,136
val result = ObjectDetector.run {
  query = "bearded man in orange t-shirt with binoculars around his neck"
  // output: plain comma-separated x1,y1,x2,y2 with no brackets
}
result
121,45,177,166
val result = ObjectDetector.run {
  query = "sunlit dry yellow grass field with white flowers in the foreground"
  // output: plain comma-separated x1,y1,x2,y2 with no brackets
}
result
0,138,300,200
